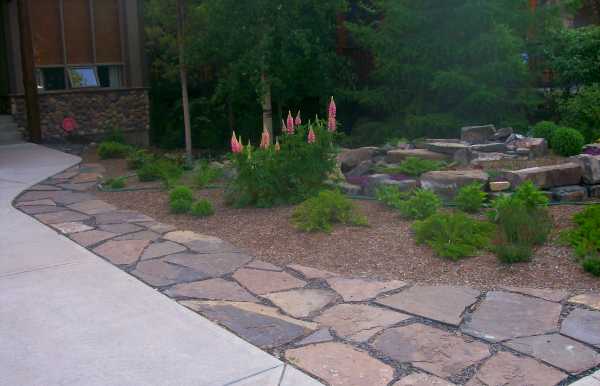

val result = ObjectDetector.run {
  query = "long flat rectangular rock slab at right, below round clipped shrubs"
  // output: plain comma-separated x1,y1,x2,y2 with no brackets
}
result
504,162,583,189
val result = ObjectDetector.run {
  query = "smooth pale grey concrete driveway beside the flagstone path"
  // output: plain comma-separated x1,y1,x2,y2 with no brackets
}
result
0,144,320,386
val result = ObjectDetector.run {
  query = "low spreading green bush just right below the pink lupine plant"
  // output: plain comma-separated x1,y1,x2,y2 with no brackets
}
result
292,190,367,233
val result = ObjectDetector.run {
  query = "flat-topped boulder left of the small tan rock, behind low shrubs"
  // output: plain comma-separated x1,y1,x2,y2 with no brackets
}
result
421,170,489,198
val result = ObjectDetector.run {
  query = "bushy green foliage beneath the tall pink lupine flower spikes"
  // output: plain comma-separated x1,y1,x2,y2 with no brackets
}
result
226,121,336,207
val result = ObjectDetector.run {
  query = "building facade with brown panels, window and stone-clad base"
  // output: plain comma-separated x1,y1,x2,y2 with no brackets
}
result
0,0,149,144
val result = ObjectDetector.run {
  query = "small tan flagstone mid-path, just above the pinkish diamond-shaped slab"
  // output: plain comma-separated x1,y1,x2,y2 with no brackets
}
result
263,289,336,318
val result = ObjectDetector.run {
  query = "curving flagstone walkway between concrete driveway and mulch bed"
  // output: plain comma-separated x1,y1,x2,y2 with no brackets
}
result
14,160,600,386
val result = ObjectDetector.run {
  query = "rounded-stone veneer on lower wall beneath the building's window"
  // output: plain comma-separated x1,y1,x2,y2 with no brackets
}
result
12,88,150,145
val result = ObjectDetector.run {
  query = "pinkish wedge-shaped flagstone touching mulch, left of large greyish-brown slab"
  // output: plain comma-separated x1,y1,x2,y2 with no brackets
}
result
327,277,408,302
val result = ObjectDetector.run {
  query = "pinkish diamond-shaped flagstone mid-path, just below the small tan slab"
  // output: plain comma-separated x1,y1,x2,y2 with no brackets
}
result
315,304,411,342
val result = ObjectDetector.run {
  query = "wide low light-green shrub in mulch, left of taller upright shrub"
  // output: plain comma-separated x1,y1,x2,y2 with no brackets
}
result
413,212,494,261
